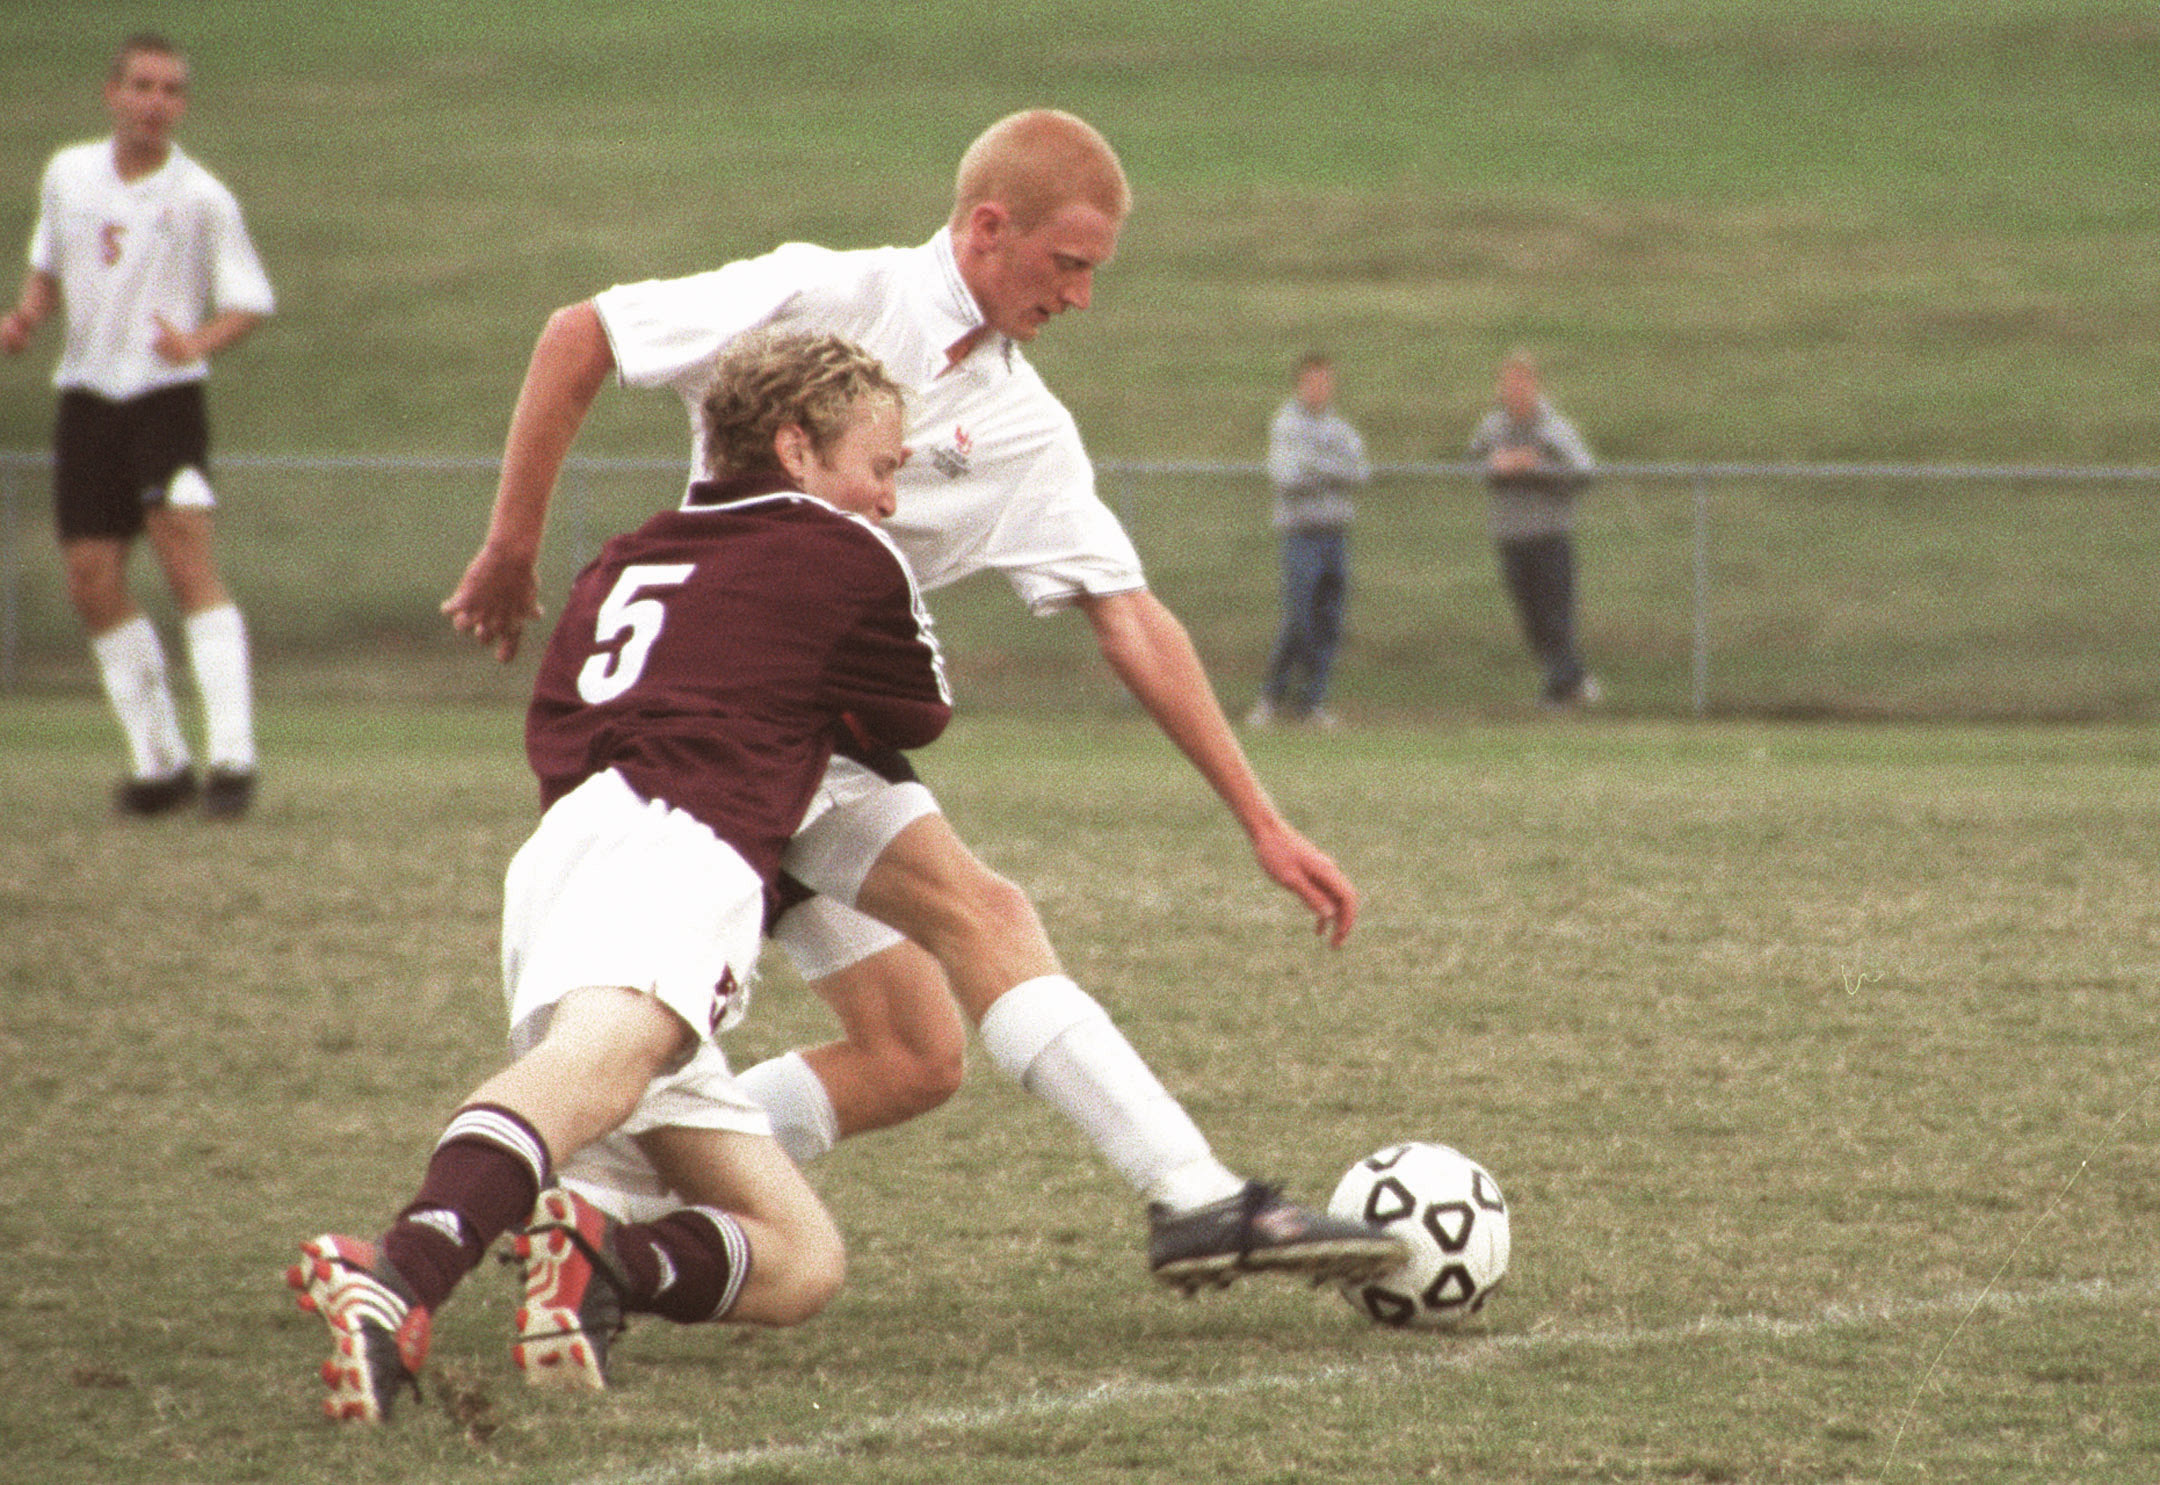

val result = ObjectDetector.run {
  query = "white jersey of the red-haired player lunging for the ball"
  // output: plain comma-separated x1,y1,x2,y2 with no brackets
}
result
594,231,1147,613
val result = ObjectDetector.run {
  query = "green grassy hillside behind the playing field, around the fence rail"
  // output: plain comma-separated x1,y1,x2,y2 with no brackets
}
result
0,0,2160,719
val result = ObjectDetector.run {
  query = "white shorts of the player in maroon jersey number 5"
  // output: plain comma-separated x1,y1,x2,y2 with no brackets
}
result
503,768,765,1055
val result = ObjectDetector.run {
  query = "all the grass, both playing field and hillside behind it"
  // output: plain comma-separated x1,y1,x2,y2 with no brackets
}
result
0,0,2160,1485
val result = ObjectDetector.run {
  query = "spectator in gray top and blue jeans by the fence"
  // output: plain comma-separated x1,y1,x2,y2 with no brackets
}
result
1246,352,1372,727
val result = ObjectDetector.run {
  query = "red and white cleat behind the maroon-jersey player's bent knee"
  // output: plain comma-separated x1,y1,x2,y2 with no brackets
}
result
510,1185,631,1392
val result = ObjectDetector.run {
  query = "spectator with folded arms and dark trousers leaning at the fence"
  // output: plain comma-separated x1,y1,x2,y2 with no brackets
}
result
1471,352,1603,708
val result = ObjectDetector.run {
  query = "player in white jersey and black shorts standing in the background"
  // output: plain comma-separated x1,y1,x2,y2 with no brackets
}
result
0,35,274,818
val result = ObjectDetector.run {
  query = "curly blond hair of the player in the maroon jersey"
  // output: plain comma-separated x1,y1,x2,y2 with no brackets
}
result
698,330,905,479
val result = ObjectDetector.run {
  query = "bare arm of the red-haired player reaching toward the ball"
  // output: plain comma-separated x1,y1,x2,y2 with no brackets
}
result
1080,587,1356,948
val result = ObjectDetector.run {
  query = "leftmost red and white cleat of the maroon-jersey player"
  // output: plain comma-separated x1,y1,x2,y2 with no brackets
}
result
285,1232,428,1422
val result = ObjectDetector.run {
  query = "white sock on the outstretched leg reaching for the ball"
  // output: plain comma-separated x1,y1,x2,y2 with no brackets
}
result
983,976,1244,1211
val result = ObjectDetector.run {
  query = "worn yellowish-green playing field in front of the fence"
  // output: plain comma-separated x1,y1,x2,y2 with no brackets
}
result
0,699,2160,1485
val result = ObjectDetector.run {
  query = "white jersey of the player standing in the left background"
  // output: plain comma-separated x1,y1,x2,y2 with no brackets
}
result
30,140,276,401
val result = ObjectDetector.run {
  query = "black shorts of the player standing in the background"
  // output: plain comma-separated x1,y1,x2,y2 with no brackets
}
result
52,382,210,542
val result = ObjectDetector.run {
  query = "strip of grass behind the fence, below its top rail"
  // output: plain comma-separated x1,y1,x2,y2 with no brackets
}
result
4,466,2160,721
